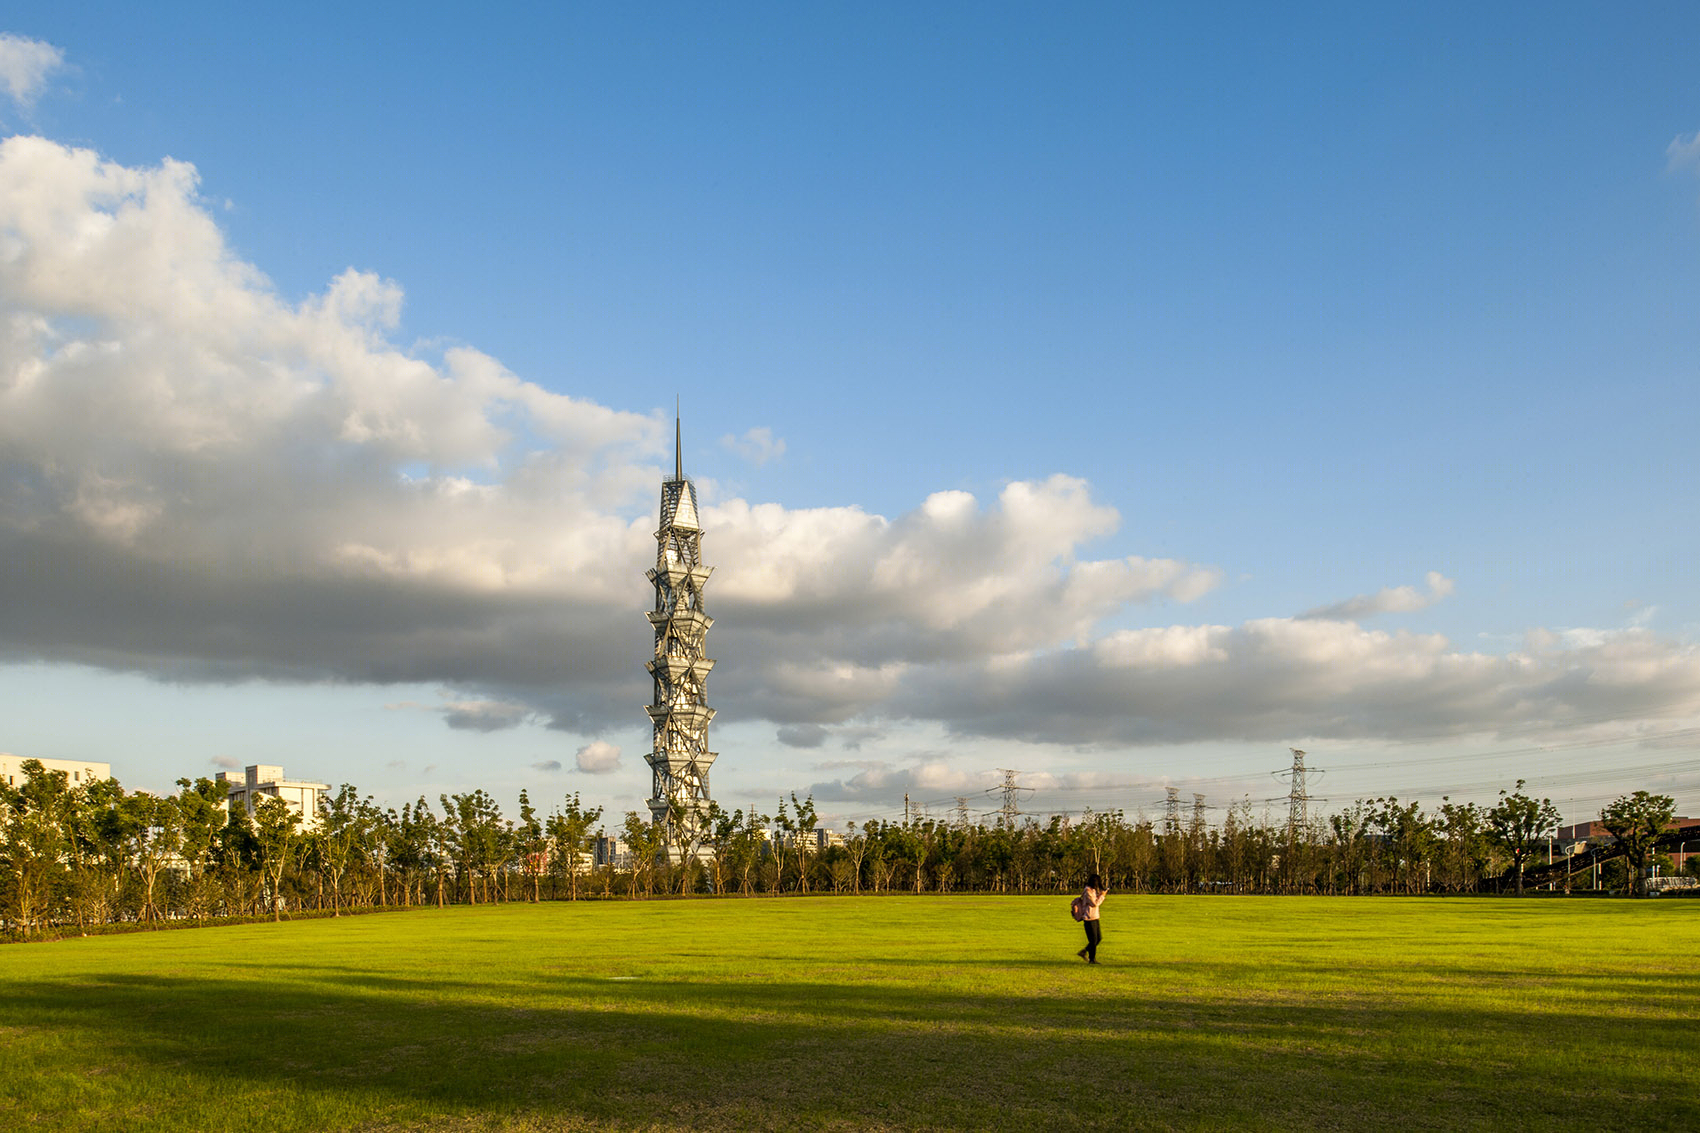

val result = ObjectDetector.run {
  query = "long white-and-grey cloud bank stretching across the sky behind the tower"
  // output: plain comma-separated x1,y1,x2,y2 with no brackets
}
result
0,138,1700,758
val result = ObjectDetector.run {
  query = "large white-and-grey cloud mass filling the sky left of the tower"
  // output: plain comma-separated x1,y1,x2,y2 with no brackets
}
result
0,138,665,728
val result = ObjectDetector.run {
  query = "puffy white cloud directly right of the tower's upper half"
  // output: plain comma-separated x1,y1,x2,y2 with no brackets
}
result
704,476,1221,723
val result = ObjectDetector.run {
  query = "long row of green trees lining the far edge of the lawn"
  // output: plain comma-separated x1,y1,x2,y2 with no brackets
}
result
0,760,1693,936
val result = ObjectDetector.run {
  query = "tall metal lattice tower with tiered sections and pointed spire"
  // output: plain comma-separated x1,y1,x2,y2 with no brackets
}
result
644,417,714,861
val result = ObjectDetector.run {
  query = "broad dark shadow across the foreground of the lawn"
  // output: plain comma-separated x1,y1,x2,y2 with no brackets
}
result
0,963,1700,1130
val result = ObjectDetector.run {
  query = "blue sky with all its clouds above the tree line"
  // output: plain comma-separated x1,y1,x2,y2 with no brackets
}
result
0,3,1700,826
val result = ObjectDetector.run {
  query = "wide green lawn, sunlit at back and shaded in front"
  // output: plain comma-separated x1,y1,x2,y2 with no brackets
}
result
0,895,1700,1131
